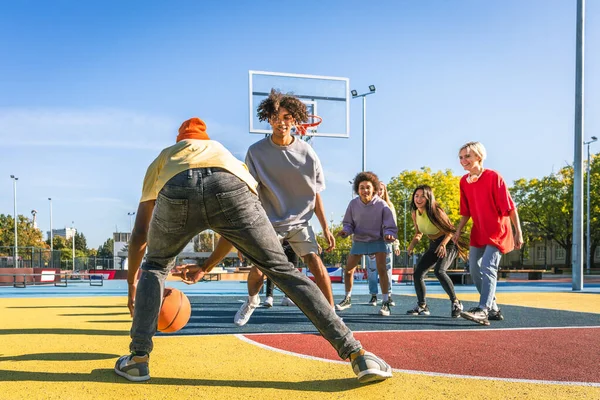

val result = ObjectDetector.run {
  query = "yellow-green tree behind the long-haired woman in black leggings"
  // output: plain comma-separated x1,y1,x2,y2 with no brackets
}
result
387,167,462,252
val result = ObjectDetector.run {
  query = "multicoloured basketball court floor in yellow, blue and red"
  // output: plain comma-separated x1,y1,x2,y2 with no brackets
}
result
0,281,600,399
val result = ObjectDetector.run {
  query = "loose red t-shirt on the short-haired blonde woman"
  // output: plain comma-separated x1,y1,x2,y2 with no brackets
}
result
460,169,515,254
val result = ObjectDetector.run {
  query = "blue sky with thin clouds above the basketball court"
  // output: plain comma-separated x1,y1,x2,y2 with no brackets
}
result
0,0,600,247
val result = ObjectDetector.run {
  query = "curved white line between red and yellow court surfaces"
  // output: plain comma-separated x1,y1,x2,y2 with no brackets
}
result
233,329,600,387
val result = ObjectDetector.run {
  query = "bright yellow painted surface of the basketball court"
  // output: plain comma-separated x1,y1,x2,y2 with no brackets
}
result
0,293,600,399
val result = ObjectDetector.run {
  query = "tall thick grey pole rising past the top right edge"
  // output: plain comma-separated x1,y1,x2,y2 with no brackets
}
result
571,0,585,291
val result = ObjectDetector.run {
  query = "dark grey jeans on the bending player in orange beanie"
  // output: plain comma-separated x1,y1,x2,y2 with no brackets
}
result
130,168,362,359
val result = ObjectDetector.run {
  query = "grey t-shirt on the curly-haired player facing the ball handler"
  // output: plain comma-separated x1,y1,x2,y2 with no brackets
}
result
246,137,325,232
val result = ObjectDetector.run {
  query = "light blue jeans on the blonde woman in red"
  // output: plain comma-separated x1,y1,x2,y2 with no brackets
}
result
469,245,502,311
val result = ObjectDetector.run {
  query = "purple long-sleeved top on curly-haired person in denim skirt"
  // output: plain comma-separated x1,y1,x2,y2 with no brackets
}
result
342,196,398,242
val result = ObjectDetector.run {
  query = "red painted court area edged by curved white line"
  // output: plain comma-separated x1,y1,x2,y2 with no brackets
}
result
247,327,600,384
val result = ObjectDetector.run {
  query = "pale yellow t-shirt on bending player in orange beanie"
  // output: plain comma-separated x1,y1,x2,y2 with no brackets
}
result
140,139,258,202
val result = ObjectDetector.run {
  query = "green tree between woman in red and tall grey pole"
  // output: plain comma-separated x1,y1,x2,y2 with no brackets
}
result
510,166,573,265
